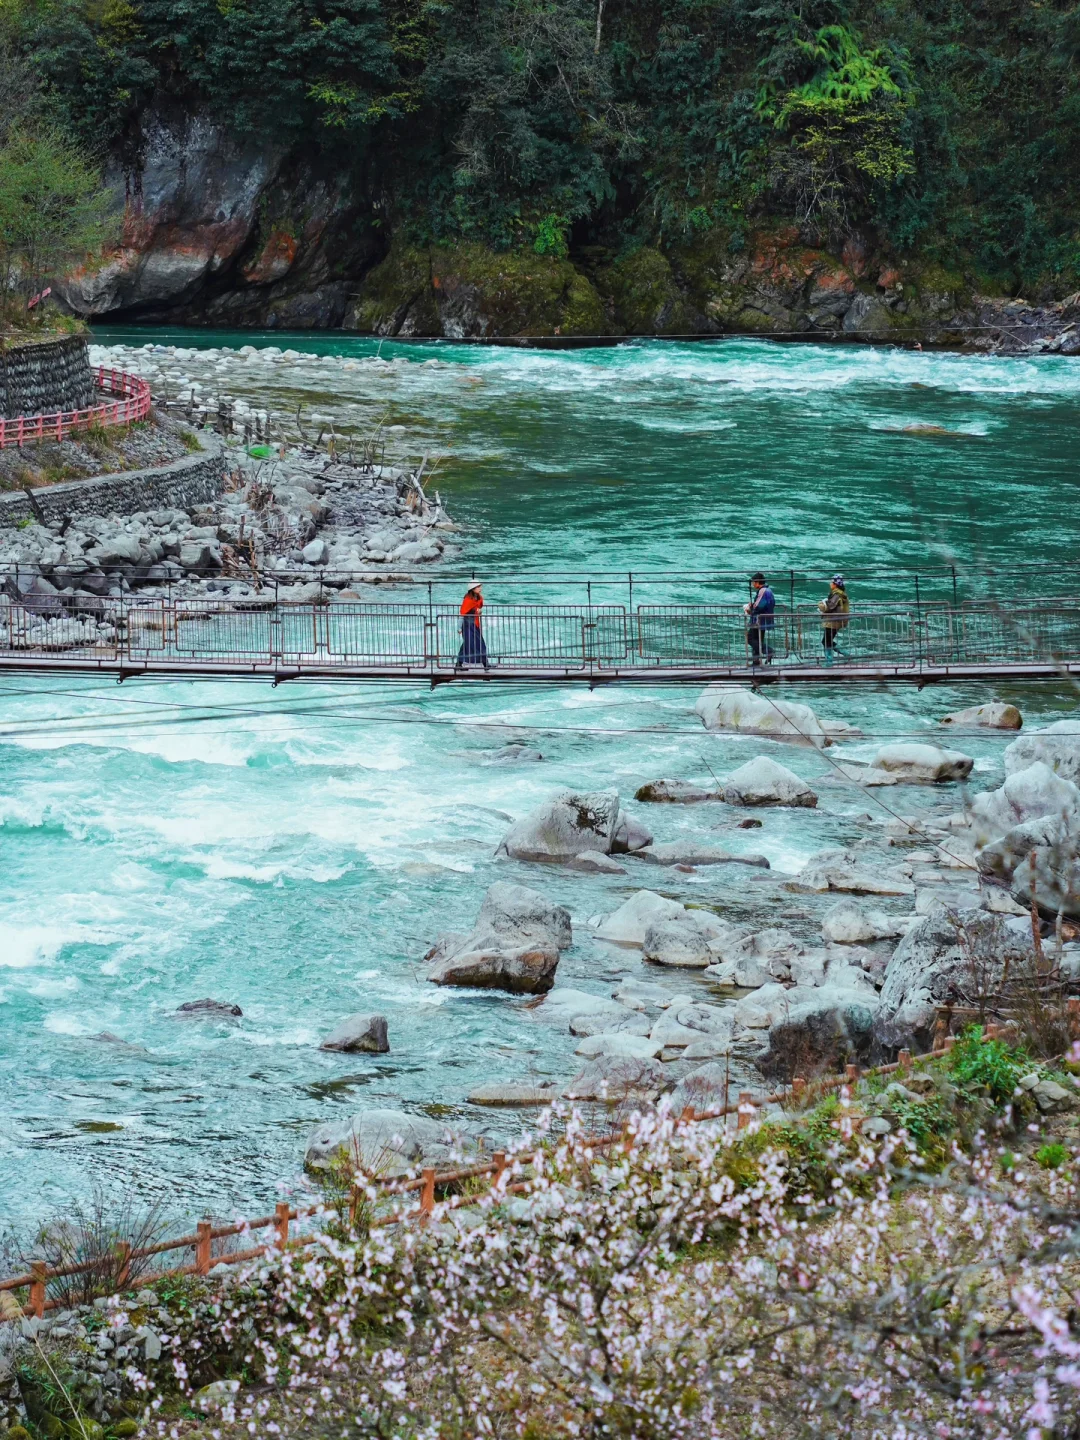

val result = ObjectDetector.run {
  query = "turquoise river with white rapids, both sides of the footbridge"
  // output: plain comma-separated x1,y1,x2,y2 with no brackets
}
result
0,331,1080,1228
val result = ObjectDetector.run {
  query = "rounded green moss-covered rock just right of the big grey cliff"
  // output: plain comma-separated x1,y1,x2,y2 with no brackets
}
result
346,245,606,340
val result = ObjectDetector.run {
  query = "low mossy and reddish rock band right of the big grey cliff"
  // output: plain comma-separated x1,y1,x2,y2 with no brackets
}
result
344,226,1080,354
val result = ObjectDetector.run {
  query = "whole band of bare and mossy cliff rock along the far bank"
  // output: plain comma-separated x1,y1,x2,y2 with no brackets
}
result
56,128,1080,354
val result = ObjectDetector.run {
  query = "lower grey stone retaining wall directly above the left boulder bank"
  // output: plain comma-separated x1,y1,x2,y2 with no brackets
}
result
0,431,225,528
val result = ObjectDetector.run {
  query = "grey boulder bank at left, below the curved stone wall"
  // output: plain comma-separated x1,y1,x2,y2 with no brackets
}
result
0,423,456,626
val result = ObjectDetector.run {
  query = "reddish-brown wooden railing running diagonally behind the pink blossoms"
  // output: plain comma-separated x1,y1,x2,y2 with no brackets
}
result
0,1031,1025,1322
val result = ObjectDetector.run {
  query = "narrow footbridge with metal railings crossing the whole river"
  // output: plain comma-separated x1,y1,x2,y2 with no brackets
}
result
0,596,1080,684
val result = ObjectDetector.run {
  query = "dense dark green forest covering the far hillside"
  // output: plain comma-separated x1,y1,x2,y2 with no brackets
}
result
0,0,1080,297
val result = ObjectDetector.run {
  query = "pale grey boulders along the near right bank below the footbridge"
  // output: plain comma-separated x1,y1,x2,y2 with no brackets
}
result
305,687,1080,1171
